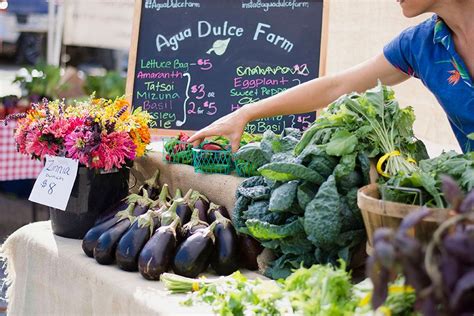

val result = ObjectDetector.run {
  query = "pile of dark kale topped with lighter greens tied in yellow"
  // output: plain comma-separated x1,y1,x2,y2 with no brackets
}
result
233,85,427,279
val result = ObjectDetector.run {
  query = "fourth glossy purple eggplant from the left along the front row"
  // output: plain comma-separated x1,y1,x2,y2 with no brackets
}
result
138,218,179,280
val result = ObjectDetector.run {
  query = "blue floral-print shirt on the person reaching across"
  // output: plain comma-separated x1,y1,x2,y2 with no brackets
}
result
384,15,474,152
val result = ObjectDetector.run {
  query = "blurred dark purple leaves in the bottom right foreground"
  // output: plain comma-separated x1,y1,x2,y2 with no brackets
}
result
368,177,474,316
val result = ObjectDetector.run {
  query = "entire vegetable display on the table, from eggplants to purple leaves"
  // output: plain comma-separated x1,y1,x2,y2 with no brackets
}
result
73,83,474,316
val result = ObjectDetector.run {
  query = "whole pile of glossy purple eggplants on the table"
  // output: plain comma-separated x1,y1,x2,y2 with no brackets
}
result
82,174,263,280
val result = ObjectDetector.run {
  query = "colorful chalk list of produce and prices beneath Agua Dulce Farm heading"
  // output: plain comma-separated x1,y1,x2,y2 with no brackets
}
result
136,58,314,133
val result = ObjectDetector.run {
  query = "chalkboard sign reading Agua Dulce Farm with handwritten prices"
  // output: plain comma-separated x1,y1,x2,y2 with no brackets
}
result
127,0,326,134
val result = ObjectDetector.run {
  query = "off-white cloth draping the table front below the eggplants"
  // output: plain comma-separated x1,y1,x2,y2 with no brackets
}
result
2,222,255,316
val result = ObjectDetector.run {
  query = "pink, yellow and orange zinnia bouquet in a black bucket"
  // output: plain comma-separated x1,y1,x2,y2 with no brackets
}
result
14,97,151,238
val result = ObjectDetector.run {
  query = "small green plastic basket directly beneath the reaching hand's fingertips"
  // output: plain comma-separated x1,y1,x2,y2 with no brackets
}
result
193,148,232,174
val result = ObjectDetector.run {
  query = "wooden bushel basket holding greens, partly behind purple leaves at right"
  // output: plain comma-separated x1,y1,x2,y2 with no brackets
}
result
357,184,450,255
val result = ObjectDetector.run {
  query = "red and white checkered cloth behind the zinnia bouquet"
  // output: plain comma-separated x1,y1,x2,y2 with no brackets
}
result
0,122,43,181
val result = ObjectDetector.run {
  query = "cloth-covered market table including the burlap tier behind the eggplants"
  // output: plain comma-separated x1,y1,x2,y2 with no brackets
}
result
3,154,257,315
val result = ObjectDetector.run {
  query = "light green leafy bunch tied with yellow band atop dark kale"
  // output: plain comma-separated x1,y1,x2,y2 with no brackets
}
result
295,82,428,175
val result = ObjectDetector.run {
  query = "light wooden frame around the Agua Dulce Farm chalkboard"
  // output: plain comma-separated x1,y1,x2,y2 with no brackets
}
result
125,0,329,136
